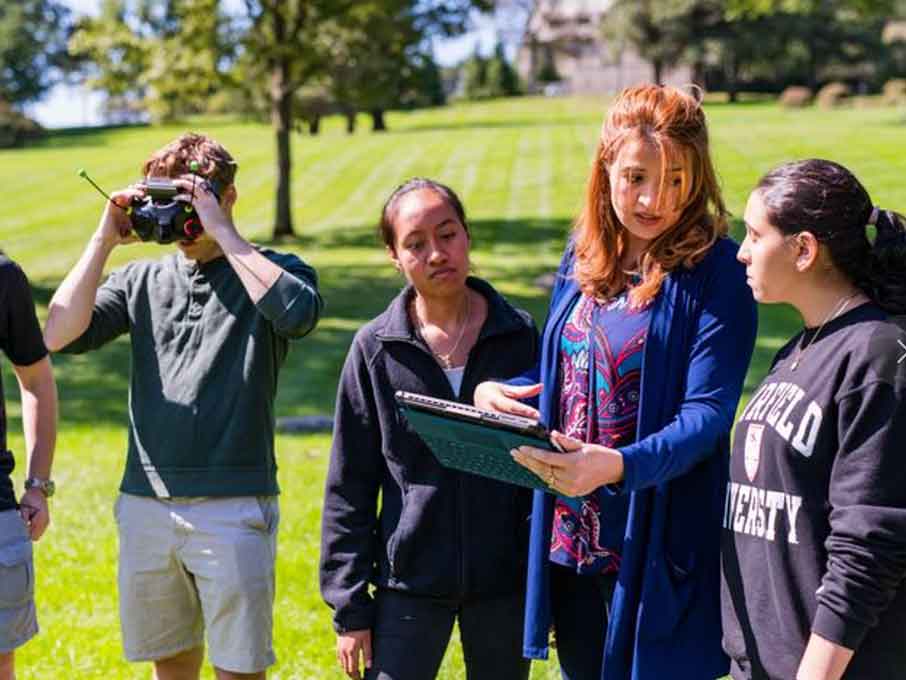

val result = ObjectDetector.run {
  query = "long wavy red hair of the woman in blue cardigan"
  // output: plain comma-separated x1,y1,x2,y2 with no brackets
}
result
573,85,727,307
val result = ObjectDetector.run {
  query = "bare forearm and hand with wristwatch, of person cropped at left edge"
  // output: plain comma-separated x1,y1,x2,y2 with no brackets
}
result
13,356,57,541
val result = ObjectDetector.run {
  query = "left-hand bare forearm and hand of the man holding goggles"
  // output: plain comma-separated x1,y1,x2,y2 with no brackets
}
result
44,188,141,352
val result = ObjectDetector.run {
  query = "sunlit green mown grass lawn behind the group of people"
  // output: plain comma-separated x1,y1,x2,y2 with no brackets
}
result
0,99,906,680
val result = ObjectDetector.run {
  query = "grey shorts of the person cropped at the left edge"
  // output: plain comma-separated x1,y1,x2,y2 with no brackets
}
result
0,510,38,654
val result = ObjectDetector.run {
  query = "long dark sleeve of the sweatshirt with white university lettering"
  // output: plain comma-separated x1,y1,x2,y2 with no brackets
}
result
812,360,906,649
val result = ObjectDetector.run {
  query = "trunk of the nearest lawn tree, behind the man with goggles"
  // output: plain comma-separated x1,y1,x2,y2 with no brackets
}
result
271,11,295,240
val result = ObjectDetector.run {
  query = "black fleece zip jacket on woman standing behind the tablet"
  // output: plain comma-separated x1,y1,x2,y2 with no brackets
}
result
320,278,538,632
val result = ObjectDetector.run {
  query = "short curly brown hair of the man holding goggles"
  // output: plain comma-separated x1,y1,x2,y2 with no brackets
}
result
142,132,239,188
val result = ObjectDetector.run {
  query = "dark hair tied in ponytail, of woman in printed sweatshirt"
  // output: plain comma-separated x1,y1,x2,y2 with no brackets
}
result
755,158,906,314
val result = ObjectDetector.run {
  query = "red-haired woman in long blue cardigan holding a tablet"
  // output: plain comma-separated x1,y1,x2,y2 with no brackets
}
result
474,85,756,680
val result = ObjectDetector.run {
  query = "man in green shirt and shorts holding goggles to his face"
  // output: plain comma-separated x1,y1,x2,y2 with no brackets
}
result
44,134,322,680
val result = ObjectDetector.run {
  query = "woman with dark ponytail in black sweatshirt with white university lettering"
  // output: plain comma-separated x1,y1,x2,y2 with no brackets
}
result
722,160,906,680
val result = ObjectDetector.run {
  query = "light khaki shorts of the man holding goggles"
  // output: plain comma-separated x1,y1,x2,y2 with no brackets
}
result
114,494,280,673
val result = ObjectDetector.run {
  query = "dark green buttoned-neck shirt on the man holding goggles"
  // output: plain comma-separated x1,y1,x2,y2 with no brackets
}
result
61,249,322,497
